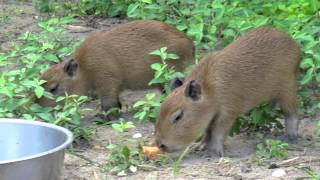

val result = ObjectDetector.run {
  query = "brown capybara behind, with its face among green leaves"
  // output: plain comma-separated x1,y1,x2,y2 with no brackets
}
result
37,20,194,110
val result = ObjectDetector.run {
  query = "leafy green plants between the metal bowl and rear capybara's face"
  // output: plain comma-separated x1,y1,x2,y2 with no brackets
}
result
0,17,94,140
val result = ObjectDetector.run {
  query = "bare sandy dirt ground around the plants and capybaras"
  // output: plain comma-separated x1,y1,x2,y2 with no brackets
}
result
0,0,320,180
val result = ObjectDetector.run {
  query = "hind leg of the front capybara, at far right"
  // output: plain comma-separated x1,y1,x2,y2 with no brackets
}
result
280,88,299,143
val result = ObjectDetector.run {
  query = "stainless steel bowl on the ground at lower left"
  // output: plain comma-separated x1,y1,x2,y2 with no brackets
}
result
0,118,73,180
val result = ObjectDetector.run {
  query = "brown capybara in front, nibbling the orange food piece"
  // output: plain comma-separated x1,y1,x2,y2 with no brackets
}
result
155,28,300,156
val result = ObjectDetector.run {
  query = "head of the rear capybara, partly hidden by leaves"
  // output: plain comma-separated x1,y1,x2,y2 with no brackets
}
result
36,59,85,106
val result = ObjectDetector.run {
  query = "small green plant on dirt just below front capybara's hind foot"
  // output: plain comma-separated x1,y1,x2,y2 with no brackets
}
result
254,139,288,165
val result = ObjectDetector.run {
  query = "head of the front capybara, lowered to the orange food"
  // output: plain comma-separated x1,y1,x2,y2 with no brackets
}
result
155,79,213,156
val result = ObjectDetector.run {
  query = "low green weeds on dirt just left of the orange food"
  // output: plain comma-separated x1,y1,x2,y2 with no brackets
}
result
102,119,171,176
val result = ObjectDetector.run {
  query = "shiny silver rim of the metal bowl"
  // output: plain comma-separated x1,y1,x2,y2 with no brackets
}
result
0,118,73,165
